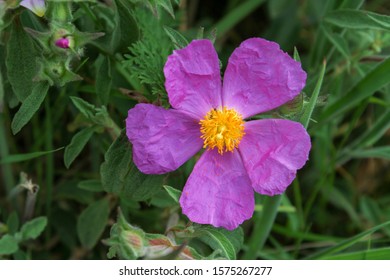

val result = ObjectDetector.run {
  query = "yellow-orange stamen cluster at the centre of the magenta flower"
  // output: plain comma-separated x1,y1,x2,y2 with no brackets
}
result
199,107,245,155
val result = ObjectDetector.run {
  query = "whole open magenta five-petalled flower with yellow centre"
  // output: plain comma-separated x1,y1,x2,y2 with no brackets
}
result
126,38,311,230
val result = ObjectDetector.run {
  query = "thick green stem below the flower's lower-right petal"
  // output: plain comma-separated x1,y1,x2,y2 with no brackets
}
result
243,195,282,260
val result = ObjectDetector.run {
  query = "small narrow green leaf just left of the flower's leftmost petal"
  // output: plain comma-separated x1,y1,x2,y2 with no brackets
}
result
64,126,95,168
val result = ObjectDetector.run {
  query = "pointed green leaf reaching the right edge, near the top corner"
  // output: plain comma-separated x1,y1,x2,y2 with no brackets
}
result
325,9,390,31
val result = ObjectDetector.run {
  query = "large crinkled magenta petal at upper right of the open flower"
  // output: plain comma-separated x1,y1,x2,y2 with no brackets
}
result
222,38,306,118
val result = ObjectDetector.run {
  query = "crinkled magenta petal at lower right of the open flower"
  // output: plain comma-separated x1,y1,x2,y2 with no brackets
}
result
239,119,311,195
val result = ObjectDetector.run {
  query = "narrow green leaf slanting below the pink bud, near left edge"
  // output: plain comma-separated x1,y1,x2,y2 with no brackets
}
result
11,82,49,134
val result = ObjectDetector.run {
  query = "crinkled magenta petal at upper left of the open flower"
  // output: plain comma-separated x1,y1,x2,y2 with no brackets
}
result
164,40,221,119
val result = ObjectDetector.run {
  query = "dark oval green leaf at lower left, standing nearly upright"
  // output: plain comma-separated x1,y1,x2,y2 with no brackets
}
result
77,199,110,249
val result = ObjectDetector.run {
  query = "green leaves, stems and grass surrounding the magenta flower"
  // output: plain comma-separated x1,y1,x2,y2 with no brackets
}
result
0,0,390,259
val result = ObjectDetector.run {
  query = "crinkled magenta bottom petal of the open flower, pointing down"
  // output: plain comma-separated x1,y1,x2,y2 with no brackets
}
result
180,149,255,230
